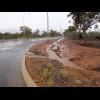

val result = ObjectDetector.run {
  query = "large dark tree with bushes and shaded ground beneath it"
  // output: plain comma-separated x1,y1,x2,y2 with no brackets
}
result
63,12,100,48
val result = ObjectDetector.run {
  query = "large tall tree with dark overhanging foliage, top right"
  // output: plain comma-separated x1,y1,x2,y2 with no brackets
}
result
67,12,100,45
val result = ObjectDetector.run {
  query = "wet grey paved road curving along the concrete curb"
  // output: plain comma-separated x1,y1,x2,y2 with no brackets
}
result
0,38,61,87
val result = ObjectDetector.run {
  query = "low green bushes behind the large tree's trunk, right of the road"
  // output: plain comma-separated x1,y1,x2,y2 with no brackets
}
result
63,25,100,40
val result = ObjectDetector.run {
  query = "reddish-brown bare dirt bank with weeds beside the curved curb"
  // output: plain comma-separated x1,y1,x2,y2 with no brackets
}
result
25,39,100,87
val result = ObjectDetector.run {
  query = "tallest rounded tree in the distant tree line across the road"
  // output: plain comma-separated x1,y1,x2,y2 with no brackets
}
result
20,26,32,37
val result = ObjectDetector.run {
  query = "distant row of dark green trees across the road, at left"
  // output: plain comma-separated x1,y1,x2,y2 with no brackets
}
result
0,26,61,39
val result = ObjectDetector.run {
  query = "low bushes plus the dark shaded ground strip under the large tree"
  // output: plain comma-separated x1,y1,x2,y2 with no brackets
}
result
63,26,100,48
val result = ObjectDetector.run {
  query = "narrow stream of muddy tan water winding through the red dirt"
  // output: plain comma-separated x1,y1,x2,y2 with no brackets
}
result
46,38,83,70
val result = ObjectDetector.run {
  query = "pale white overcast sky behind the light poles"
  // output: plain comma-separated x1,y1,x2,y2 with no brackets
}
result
0,12,99,33
